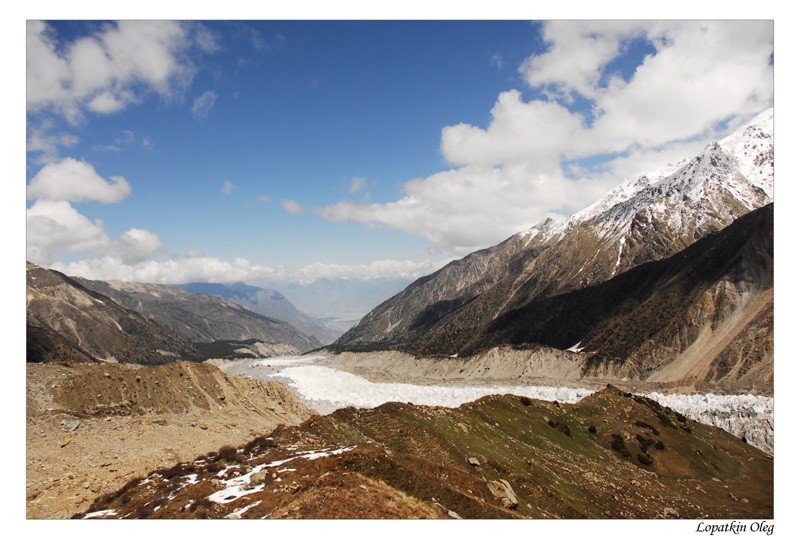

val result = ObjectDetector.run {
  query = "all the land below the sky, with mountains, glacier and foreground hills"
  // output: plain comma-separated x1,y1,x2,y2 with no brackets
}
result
26,104,775,519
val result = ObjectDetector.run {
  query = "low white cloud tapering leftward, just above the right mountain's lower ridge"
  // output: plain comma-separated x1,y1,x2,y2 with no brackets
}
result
315,164,614,254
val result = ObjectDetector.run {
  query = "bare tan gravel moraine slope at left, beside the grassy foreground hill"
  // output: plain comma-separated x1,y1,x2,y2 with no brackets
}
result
25,362,315,518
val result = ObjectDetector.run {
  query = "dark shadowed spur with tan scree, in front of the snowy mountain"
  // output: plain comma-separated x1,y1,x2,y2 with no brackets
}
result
440,204,773,393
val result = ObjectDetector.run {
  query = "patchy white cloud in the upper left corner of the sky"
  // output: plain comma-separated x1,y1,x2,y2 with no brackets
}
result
26,21,211,123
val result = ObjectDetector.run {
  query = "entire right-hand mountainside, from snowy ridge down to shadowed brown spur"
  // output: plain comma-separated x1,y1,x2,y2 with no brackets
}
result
330,111,773,392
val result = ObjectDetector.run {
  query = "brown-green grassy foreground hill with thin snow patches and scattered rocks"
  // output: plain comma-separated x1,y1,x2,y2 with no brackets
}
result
75,387,774,519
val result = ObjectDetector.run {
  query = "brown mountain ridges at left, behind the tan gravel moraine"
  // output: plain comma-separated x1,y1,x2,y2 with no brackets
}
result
26,263,321,364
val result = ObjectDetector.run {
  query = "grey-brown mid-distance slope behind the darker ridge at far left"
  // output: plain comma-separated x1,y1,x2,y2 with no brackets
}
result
76,278,321,353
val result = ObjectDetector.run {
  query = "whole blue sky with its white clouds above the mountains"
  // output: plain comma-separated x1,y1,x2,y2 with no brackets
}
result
25,15,774,285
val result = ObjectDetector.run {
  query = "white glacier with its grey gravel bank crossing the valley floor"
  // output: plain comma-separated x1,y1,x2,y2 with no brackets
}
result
215,351,775,454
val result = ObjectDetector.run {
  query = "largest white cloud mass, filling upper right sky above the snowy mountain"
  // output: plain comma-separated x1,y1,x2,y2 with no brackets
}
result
314,21,773,254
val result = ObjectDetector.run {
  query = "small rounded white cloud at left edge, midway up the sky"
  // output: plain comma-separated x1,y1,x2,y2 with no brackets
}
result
28,158,131,203
